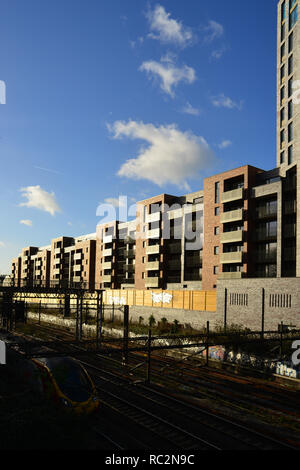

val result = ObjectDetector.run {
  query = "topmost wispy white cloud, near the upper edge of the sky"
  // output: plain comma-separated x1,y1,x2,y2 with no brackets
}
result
147,5,194,47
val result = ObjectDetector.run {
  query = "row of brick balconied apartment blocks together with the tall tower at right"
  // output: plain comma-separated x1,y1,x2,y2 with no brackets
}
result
12,0,300,290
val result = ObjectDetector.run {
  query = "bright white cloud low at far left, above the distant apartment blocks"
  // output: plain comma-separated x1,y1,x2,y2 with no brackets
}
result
20,186,61,215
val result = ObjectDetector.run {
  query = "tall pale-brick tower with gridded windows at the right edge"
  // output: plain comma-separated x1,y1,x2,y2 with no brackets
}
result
277,0,300,277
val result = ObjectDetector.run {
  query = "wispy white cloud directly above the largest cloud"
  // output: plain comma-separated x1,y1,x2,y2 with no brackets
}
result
139,55,196,97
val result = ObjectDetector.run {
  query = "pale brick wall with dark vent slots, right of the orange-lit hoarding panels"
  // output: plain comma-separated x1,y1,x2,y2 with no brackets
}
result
217,278,300,330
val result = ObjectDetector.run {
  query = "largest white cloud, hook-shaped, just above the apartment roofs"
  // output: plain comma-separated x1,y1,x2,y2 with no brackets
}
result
108,121,214,190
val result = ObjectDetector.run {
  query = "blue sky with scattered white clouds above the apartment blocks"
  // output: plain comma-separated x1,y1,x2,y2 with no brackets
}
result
0,0,277,273
